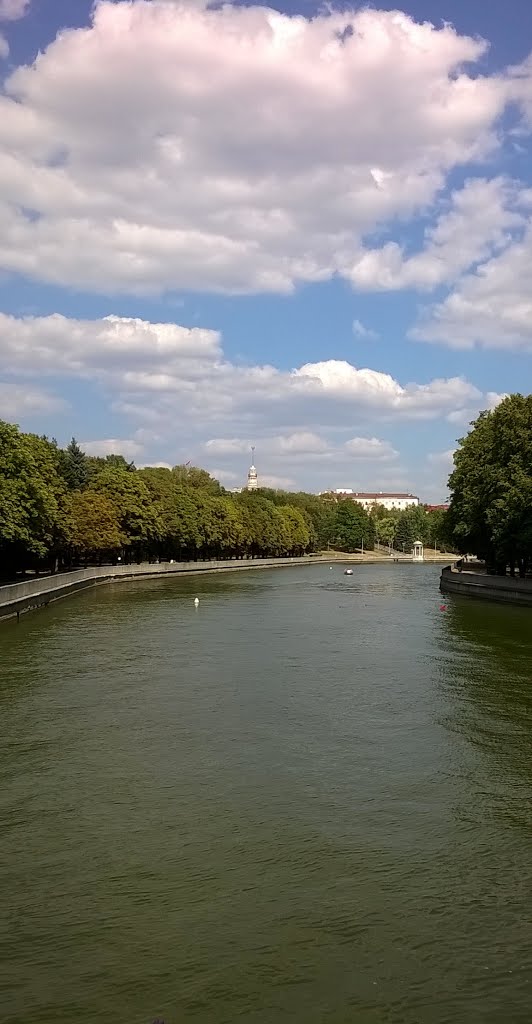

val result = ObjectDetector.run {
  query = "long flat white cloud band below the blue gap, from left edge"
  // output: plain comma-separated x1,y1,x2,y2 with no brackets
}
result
0,314,480,428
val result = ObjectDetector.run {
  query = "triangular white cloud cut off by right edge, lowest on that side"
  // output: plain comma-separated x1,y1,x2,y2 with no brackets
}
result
410,219,532,352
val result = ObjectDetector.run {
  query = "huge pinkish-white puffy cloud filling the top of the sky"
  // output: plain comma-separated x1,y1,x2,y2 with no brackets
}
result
0,0,517,293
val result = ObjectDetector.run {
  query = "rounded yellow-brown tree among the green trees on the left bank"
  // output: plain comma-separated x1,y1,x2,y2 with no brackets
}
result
67,490,127,558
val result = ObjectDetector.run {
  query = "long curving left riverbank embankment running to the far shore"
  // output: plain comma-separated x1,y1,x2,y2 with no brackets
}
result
0,551,449,622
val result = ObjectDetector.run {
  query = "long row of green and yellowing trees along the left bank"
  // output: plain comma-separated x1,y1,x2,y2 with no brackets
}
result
0,421,448,579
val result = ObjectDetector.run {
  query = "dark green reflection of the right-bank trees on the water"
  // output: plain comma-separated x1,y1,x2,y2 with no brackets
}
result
437,600,532,829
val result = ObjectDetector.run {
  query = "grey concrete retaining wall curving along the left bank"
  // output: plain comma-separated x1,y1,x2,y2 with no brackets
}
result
0,555,319,620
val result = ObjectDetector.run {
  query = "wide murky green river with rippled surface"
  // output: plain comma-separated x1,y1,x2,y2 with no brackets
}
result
0,564,532,1024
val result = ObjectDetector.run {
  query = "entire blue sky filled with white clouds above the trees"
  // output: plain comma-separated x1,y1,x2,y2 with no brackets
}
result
0,0,532,502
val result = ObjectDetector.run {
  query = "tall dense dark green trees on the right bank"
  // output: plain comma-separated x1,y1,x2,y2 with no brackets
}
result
447,394,532,577
